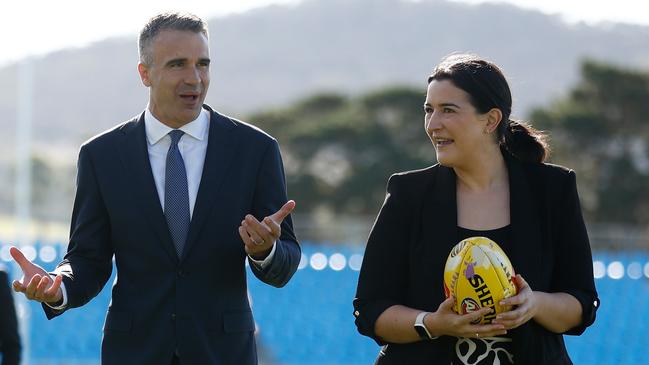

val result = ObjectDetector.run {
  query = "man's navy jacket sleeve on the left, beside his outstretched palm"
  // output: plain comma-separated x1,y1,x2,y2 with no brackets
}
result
43,145,113,319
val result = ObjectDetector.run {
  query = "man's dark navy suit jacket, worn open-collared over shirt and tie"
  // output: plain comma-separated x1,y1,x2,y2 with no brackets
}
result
44,106,300,365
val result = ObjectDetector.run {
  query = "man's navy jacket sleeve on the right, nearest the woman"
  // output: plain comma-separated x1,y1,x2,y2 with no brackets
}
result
250,139,301,287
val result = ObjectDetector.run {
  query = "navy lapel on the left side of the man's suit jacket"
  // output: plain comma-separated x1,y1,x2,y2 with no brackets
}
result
119,113,178,262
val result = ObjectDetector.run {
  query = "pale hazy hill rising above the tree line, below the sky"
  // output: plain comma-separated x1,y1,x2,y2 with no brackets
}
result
0,0,649,156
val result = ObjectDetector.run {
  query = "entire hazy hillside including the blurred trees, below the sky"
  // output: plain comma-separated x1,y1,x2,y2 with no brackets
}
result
0,0,649,236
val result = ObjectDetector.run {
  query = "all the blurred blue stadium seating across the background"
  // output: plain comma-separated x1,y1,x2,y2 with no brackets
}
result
0,242,649,365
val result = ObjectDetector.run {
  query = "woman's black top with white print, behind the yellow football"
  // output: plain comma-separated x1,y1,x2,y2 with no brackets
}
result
452,225,514,365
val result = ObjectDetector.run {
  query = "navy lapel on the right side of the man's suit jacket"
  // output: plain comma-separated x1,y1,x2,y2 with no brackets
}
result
182,105,236,259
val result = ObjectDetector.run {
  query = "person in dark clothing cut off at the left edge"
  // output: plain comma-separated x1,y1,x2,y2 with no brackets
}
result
0,264,20,365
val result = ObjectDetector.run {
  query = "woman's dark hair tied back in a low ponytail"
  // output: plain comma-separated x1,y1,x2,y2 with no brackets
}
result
428,54,550,162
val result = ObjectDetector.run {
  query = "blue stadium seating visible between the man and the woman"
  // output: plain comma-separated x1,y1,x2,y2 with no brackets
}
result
249,244,378,365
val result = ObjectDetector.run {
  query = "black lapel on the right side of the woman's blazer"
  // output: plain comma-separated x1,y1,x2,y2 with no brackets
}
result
505,154,543,288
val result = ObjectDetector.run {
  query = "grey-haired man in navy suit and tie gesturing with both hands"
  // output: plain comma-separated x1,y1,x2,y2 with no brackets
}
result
10,13,300,365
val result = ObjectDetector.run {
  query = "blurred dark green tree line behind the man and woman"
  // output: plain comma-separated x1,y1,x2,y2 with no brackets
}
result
10,61,649,230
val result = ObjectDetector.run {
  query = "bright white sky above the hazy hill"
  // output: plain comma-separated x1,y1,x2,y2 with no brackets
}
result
0,0,649,66
